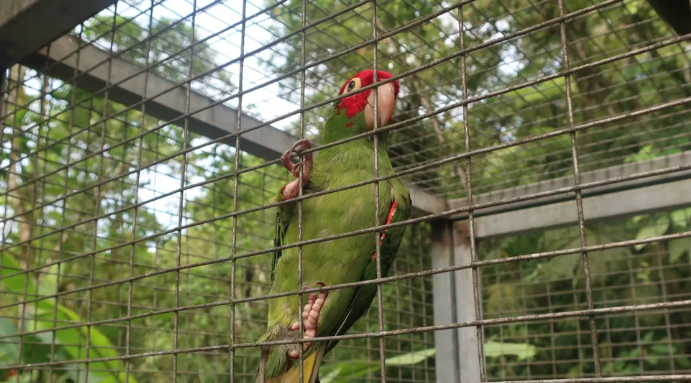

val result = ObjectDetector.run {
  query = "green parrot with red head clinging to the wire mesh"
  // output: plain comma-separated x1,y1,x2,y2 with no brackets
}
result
255,69,412,383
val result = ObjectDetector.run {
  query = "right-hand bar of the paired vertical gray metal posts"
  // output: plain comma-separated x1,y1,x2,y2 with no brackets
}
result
453,222,481,383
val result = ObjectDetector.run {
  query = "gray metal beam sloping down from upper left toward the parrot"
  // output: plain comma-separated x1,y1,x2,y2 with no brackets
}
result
26,36,295,159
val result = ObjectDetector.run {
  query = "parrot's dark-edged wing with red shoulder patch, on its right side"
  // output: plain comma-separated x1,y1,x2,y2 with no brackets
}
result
324,191,412,354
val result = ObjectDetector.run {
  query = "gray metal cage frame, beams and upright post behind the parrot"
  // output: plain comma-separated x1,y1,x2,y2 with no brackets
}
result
12,36,691,383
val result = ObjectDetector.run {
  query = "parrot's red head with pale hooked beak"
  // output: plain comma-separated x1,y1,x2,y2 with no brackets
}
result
336,69,398,129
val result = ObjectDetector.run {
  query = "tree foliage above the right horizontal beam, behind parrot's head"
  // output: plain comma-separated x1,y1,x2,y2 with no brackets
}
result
265,0,691,198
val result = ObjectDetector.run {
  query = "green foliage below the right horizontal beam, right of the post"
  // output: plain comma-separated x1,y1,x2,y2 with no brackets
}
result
478,207,691,378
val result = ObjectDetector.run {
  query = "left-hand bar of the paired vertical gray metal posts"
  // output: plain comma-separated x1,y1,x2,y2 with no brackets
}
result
431,221,460,383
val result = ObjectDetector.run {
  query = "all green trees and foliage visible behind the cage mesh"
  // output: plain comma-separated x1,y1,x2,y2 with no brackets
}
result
0,0,691,383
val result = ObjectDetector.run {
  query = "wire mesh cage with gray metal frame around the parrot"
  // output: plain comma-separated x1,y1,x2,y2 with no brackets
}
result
0,0,691,383
